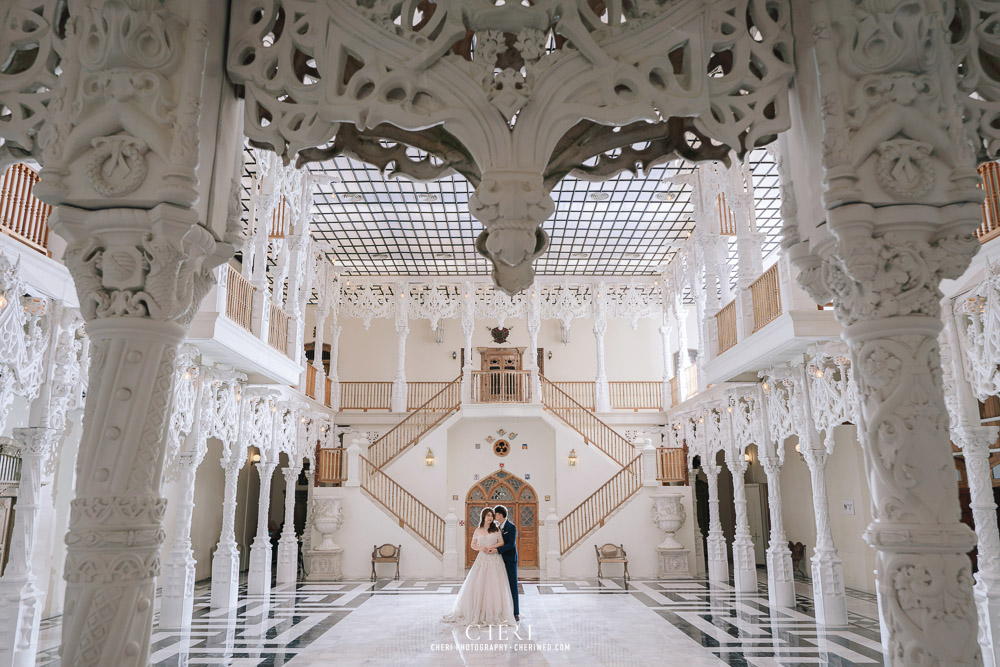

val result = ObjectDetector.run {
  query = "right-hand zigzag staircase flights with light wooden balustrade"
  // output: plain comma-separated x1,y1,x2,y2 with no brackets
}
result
542,377,642,556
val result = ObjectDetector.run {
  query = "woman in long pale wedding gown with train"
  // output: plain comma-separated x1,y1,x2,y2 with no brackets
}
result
444,507,516,625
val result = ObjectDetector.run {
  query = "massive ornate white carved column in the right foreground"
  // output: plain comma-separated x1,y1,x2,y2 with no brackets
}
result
784,1,996,666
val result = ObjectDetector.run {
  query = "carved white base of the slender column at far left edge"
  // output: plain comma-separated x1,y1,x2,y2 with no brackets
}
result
0,577,45,667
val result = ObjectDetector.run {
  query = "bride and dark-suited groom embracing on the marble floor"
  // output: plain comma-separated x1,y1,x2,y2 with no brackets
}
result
444,505,520,625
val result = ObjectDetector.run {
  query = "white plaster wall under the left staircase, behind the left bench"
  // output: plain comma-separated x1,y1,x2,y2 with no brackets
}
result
313,487,441,579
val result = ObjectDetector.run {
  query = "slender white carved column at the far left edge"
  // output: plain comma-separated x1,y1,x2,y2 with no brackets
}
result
0,426,61,667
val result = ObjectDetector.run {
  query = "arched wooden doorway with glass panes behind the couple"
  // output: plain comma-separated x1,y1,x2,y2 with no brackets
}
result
465,470,538,567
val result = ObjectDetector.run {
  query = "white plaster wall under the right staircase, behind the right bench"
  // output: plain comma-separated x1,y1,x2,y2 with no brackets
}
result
560,486,695,578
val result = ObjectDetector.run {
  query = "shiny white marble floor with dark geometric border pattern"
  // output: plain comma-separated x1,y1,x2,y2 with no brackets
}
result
37,572,882,667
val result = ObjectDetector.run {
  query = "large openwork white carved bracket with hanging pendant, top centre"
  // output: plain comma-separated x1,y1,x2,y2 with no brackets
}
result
228,0,792,294
